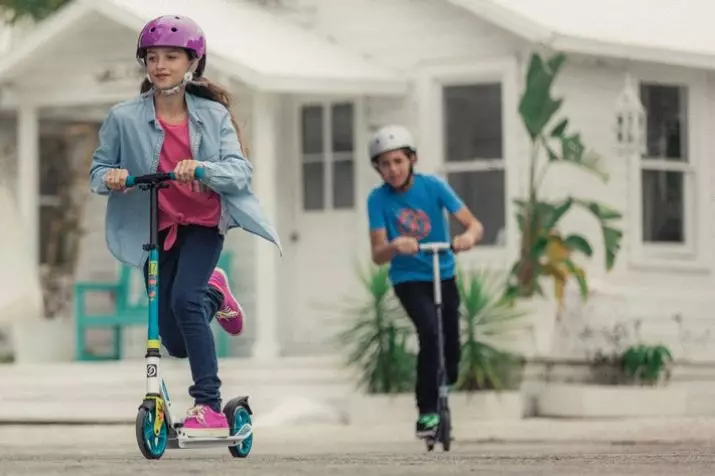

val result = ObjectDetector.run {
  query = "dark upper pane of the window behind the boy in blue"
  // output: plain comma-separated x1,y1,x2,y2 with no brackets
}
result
444,83,503,162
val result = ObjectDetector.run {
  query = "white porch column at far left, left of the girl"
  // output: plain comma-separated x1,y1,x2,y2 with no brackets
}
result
16,102,40,265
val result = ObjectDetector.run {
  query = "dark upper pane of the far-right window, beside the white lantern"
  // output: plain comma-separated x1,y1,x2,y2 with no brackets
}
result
641,84,688,161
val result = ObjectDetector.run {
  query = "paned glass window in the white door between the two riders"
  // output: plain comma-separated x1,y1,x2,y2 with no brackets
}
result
301,103,355,211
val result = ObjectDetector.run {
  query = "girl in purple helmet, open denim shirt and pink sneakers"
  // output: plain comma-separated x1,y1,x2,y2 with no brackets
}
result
90,15,280,436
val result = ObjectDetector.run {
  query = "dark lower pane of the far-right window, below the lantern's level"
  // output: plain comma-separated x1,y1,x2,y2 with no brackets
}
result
643,170,685,243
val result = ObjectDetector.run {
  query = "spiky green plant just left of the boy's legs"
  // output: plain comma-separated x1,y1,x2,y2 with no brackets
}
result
337,263,415,393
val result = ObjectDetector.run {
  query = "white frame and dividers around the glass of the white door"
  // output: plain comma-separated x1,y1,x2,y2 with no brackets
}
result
294,96,364,214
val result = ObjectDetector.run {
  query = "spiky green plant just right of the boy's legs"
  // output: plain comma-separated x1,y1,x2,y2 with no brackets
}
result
455,270,525,391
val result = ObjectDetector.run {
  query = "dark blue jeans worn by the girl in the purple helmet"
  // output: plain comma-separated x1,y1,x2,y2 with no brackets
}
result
144,225,223,411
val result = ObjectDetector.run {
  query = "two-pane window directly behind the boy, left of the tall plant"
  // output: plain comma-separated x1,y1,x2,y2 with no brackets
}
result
443,83,506,246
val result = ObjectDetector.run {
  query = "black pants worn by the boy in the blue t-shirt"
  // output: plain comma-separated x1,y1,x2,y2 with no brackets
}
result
394,279,461,414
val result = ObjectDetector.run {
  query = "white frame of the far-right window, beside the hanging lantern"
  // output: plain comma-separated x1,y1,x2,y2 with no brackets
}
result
626,68,711,272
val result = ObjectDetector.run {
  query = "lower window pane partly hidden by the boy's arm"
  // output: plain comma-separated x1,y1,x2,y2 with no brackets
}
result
447,170,506,245
